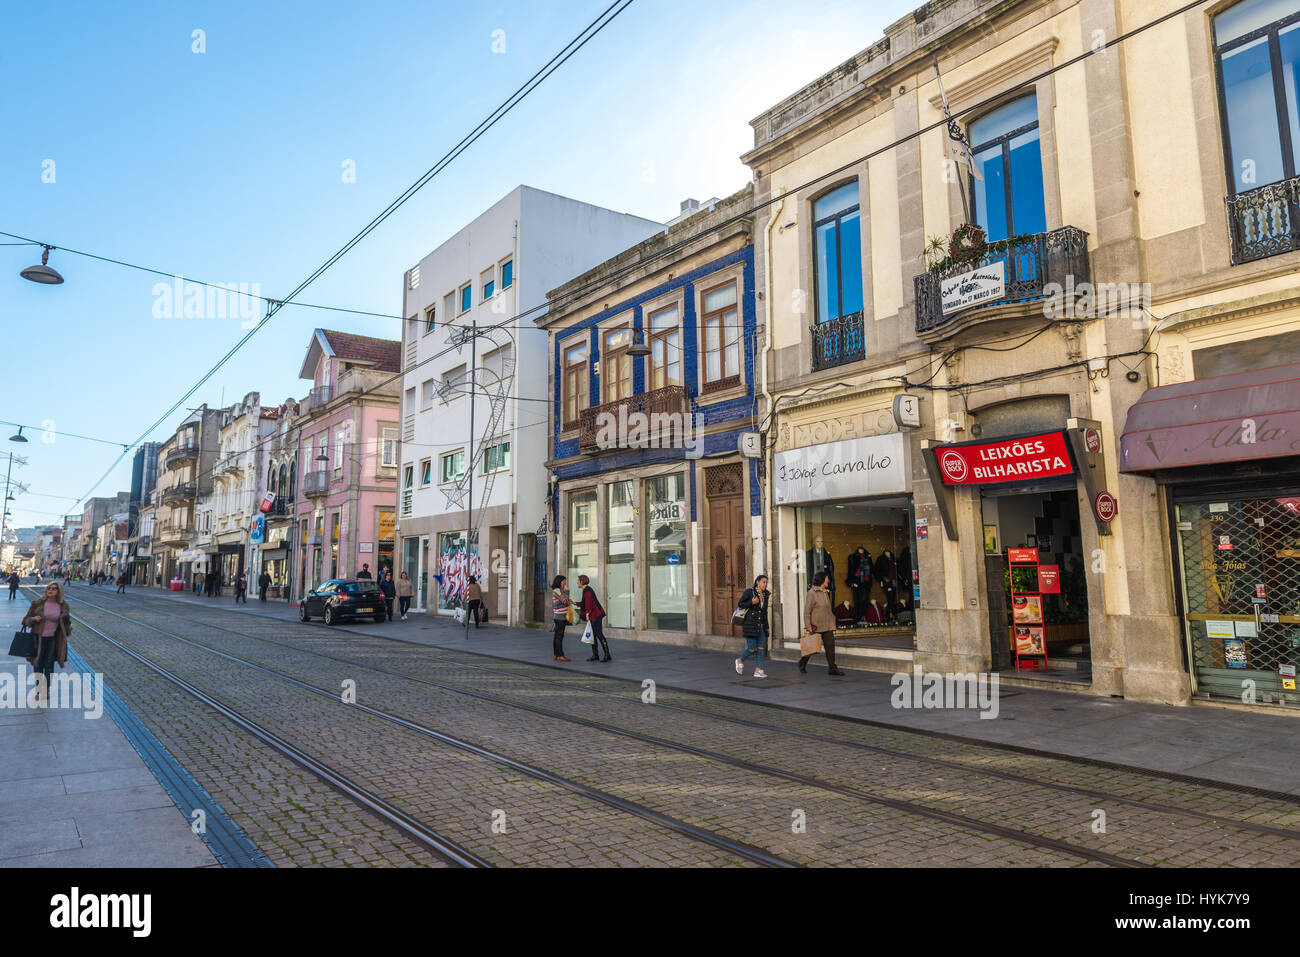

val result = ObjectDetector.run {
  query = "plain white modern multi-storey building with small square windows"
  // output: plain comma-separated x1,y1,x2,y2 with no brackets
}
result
398,186,664,624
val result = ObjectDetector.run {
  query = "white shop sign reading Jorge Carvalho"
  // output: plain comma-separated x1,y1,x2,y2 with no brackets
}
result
772,432,910,505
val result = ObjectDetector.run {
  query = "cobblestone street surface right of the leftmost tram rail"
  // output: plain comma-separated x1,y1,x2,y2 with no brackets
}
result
63,590,1300,866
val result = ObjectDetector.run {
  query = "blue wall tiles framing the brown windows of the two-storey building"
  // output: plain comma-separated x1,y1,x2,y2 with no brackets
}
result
551,246,761,521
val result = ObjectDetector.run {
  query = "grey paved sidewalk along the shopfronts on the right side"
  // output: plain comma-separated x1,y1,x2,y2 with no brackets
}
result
83,585,1300,796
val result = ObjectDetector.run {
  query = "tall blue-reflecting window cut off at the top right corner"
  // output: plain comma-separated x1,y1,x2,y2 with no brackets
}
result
1214,0,1300,192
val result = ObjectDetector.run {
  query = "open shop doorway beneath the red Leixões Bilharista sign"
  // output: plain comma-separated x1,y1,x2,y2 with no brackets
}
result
982,482,1092,681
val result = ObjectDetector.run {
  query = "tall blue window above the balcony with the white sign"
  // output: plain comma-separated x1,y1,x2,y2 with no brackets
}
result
970,94,1048,242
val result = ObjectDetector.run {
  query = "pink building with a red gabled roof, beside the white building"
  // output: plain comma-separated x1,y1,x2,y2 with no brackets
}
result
293,329,402,598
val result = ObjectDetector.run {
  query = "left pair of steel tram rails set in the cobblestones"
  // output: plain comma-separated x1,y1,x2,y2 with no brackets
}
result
63,601,798,867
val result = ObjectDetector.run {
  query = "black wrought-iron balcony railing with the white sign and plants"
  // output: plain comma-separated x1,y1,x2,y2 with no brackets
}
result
913,226,1091,335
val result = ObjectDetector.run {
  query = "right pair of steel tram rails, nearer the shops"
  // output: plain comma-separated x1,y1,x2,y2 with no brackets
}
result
68,590,1170,867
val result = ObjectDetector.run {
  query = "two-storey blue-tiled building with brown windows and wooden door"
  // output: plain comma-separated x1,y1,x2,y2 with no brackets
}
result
538,189,762,644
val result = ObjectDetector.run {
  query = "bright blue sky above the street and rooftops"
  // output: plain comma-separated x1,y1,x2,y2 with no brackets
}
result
0,0,915,527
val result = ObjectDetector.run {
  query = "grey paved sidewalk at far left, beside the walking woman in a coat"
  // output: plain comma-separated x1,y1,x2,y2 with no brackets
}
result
0,589,217,867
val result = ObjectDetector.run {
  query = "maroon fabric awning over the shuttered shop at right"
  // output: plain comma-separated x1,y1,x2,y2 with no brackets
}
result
1119,363,1300,472
